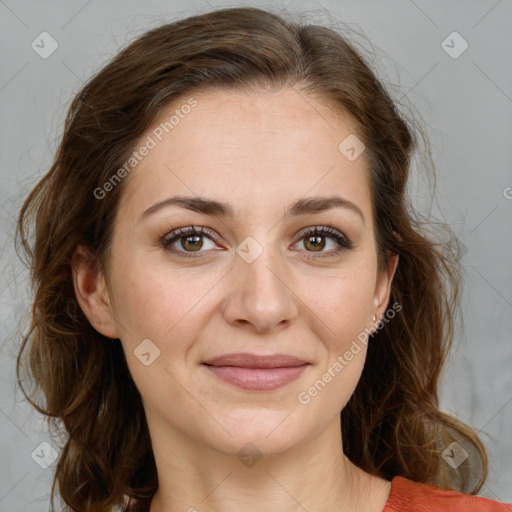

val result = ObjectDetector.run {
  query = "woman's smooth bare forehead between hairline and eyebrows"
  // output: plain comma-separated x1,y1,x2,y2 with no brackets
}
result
116,88,371,222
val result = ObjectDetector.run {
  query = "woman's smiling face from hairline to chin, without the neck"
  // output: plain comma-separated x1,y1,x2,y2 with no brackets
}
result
79,88,397,453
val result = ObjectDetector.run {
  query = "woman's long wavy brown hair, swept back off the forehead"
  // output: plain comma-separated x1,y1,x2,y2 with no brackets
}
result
17,8,487,511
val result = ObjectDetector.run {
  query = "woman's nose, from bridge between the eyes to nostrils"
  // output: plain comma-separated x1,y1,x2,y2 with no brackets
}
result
223,228,299,333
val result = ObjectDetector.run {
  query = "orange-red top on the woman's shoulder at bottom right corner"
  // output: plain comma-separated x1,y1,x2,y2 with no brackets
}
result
382,476,512,512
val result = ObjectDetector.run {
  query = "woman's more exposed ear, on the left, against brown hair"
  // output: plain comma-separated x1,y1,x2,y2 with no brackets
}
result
71,245,119,338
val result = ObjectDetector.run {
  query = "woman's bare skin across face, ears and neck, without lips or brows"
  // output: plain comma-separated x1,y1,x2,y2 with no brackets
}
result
74,88,398,512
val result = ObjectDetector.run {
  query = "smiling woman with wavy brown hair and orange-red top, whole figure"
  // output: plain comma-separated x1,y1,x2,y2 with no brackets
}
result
14,8,511,512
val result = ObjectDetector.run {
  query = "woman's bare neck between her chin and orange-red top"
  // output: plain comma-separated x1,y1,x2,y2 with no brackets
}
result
146,415,390,512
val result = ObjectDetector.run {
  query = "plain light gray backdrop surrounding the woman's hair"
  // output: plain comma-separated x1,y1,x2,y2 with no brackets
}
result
0,0,512,512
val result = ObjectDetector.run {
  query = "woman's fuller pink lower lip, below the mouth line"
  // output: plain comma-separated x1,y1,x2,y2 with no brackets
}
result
204,364,308,391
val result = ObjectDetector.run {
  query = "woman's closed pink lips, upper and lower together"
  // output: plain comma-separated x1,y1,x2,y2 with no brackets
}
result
203,353,309,391
